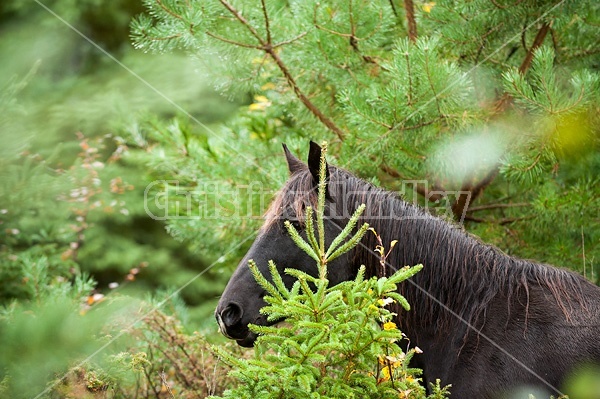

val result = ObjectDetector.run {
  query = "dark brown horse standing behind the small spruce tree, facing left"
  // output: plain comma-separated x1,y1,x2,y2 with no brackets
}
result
215,142,600,398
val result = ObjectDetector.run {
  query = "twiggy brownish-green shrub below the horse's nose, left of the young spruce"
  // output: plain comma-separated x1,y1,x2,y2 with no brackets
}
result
107,299,247,399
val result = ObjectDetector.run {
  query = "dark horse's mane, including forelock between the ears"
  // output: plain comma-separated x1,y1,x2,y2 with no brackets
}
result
264,166,585,338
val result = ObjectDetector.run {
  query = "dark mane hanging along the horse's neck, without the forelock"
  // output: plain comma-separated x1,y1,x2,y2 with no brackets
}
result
342,181,585,344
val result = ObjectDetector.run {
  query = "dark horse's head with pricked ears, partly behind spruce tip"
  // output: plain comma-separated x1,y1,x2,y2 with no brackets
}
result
215,142,356,347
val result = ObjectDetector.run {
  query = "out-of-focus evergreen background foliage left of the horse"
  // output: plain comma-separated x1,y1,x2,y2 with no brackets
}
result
0,0,235,312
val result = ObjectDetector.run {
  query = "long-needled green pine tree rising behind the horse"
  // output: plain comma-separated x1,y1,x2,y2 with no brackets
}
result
132,0,600,280
